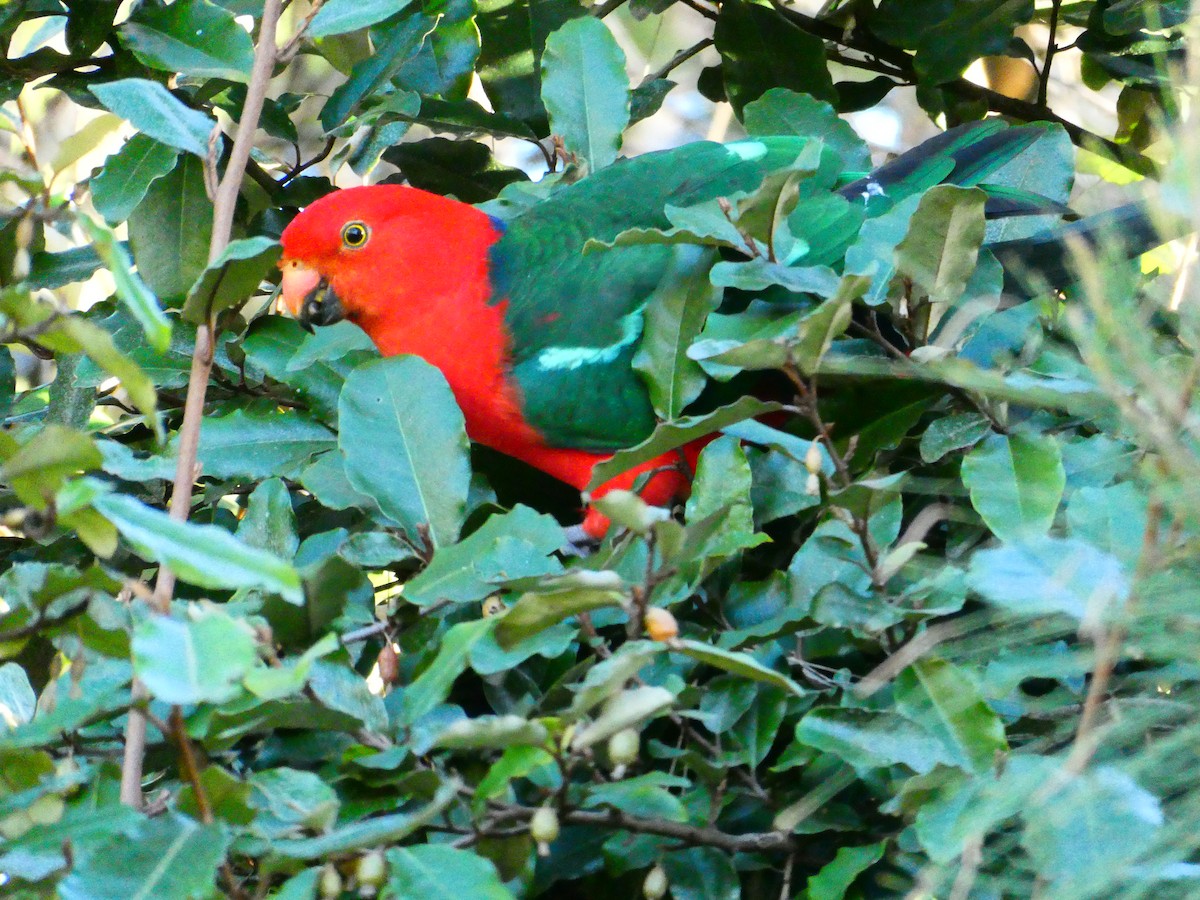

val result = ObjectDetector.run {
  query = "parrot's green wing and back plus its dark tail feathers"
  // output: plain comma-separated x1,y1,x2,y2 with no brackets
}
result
492,119,1171,451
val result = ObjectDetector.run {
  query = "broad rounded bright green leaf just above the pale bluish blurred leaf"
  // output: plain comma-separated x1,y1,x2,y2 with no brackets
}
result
962,434,1067,540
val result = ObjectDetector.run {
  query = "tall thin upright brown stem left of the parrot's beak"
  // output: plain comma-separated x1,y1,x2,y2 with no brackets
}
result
121,0,280,809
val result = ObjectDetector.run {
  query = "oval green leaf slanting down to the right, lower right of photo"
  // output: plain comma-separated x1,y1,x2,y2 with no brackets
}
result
895,659,1008,772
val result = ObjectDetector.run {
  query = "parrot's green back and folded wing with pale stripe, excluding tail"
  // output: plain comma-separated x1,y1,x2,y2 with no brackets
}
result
492,137,825,450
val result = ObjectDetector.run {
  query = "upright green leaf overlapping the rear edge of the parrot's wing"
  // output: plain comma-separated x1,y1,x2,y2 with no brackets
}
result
634,247,721,420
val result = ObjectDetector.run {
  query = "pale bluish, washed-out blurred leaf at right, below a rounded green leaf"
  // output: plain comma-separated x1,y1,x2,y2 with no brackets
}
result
967,536,1130,622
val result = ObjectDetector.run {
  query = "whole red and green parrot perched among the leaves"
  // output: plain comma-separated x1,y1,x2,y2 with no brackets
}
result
280,120,1171,536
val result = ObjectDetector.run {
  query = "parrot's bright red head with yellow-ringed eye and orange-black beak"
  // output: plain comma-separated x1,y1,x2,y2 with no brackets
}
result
280,185,497,325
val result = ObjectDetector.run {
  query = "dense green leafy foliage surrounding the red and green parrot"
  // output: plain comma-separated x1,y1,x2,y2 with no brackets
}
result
0,0,1200,900
